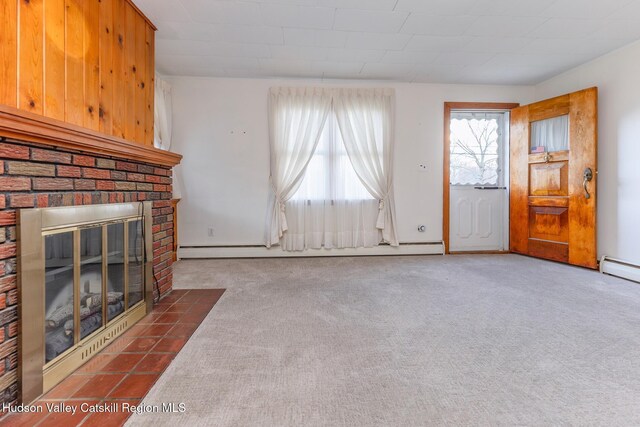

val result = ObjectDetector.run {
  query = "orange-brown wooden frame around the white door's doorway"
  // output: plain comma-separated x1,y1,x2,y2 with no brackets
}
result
442,102,520,254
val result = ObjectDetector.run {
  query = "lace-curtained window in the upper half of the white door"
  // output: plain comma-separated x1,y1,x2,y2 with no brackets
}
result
450,111,508,187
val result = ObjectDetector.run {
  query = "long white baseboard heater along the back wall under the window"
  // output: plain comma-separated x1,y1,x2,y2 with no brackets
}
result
178,242,444,259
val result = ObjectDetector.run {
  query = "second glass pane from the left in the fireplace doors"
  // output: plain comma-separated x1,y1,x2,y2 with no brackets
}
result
80,227,102,338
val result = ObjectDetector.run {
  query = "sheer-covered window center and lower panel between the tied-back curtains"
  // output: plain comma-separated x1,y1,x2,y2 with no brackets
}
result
281,112,382,251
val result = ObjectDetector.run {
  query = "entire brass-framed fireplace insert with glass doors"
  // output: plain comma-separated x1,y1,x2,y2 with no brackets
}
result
18,202,153,403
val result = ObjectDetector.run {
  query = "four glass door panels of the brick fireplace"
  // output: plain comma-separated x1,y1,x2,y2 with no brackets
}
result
44,218,142,363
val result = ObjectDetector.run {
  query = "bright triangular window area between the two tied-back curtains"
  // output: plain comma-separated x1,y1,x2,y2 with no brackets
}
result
292,112,373,201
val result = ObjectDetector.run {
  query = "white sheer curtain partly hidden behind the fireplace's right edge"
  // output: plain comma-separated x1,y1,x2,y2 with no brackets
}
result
153,74,182,199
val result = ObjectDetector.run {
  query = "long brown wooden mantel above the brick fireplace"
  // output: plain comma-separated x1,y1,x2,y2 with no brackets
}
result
0,105,182,167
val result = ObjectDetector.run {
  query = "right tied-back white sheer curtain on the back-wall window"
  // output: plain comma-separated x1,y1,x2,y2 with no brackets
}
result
333,89,398,246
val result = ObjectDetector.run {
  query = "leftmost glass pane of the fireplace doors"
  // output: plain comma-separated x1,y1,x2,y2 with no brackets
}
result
44,231,74,362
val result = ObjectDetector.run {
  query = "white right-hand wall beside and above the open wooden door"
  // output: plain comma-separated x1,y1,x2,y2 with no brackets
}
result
535,42,640,264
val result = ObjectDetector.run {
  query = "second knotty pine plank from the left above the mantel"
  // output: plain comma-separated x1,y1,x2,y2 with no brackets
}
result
18,0,44,114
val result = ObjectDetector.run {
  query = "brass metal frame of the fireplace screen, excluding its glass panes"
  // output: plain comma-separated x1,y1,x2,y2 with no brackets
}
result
18,202,153,403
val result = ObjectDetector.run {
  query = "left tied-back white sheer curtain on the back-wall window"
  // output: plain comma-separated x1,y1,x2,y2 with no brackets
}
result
266,88,331,247
